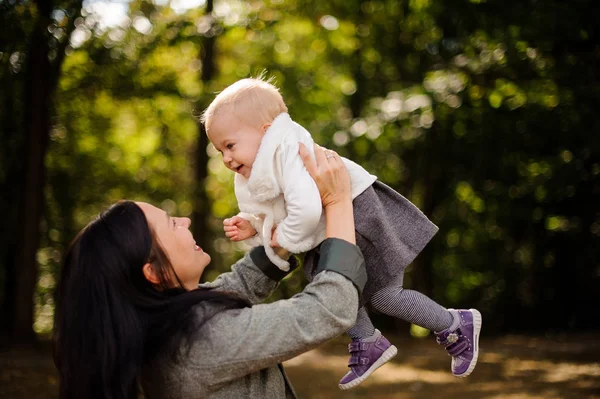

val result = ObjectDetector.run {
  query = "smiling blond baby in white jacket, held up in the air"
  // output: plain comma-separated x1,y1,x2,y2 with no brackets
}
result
202,78,482,389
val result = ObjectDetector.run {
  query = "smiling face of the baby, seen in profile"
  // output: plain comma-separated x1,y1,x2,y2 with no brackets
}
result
208,115,268,179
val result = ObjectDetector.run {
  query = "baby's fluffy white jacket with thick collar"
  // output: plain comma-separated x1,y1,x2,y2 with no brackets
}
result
235,113,377,271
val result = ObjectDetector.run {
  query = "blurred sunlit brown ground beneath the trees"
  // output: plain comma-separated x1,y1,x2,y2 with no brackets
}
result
0,334,600,399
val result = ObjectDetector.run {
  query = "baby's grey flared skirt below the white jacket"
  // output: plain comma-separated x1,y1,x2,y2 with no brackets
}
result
304,181,438,302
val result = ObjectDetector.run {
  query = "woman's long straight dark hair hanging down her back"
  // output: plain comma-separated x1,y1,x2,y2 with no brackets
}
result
54,201,244,399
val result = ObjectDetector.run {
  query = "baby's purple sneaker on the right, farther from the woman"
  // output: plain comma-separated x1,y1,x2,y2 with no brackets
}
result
435,309,481,377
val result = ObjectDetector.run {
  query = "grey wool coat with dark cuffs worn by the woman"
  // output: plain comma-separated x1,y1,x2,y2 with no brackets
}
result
142,239,366,399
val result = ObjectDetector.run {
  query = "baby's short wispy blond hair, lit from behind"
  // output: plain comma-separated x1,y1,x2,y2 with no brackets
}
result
200,75,288,131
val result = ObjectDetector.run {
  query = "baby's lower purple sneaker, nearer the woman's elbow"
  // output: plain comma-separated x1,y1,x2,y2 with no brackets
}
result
339,330,398,389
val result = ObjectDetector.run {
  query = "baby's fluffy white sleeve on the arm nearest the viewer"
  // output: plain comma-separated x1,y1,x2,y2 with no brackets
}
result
276,143,323,253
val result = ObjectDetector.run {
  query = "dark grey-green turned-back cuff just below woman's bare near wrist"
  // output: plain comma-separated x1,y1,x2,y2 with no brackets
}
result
317,238,367,294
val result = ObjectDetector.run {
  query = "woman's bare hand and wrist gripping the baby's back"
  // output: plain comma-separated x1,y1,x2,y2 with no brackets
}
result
298,143,356,244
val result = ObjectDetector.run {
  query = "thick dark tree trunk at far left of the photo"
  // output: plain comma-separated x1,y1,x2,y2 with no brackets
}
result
4,0,83,344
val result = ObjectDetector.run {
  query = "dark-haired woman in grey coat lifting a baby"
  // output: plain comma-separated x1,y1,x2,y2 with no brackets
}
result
54,147,366,399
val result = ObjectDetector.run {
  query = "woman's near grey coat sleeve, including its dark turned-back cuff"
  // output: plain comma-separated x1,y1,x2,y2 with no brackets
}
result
185,239,366,386
